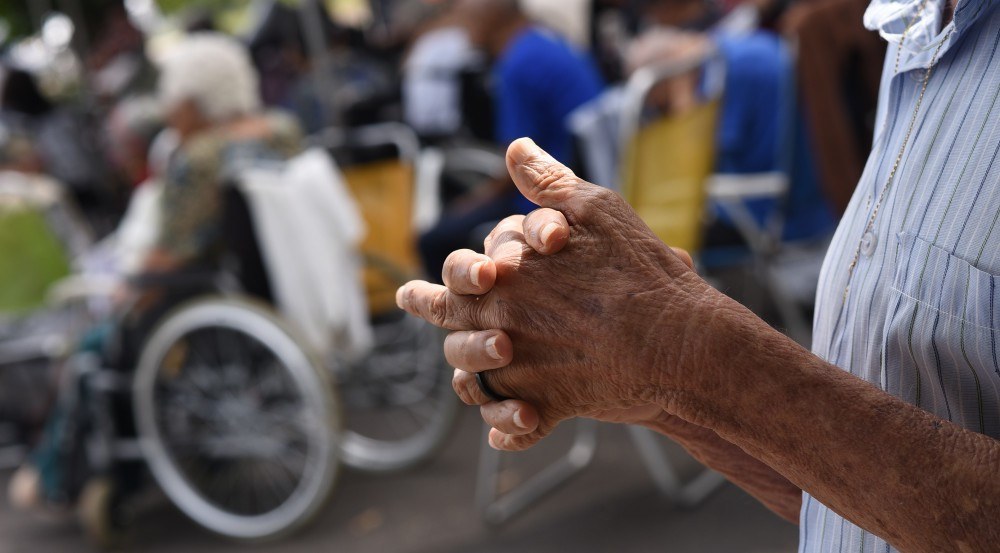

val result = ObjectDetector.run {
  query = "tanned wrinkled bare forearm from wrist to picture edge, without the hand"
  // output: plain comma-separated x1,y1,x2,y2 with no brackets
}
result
680,301,1000,551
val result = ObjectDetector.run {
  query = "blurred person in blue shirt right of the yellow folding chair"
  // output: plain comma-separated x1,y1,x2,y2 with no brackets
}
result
643,0,835,248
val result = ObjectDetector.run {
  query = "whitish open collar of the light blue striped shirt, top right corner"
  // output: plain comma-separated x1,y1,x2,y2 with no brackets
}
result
864,0,1000,73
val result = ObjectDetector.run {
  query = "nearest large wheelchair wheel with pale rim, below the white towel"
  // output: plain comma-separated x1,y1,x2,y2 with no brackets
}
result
133,298,340,541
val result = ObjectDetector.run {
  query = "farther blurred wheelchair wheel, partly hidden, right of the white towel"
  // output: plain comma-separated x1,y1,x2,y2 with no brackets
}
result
334,258,458,472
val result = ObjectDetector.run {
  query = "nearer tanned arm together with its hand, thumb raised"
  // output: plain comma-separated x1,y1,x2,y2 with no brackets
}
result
397,140,1000,552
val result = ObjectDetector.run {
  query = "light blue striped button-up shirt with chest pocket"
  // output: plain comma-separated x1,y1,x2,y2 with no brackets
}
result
799,0,1000,553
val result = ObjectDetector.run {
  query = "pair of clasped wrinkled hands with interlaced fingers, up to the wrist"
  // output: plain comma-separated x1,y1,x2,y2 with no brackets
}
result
397,139,709,450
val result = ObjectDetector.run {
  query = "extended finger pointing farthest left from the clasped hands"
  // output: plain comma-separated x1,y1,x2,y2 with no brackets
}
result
396,280,484,330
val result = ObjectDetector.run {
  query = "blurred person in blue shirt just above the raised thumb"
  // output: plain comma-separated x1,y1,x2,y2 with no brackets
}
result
419,0,604,278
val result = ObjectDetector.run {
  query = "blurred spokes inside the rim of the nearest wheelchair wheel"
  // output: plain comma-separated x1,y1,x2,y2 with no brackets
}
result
150,328,323,514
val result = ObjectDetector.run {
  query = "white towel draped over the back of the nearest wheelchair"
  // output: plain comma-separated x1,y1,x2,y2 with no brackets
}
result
238,149,374,359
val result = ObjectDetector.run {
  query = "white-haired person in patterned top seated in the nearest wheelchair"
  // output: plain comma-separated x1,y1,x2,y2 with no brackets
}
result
9,33,301,509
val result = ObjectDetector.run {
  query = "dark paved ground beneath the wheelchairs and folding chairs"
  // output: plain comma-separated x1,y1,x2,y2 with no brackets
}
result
0,409,797,553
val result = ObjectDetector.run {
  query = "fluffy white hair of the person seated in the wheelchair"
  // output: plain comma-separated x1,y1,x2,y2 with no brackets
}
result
159,32,261,122
